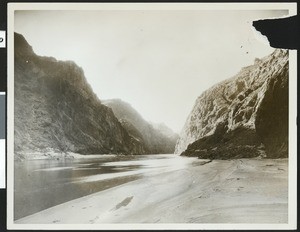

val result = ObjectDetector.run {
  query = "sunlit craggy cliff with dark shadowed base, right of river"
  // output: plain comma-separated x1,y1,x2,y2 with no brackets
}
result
175,50,288,159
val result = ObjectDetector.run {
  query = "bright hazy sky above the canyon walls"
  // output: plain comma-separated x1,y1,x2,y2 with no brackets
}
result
15,10,288,132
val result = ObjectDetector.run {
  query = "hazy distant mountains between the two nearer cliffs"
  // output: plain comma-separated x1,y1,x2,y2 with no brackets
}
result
102,99,178,154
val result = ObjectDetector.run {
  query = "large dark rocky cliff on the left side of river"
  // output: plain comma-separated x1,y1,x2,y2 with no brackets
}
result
14,33,143,158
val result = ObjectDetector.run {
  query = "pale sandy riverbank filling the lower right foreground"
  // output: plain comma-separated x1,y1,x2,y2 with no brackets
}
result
15,159,288,224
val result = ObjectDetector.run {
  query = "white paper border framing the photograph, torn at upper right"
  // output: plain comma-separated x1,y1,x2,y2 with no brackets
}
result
7,2,297,230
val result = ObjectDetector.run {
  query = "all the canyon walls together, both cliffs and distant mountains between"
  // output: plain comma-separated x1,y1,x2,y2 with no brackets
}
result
14,33,288,159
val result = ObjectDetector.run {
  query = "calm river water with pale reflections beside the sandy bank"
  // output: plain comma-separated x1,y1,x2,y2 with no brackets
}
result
14,154,191,220
